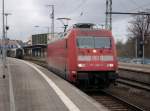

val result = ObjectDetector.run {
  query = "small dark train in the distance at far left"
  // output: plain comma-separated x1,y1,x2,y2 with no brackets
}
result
7,48,24,59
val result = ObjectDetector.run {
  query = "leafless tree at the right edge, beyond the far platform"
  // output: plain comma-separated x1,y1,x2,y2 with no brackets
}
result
128,10,150,57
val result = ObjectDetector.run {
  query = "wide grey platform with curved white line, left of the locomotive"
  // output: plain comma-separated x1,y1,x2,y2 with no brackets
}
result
0,58,108,111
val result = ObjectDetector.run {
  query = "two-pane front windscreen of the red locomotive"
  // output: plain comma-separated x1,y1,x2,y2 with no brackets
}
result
77,36,111,48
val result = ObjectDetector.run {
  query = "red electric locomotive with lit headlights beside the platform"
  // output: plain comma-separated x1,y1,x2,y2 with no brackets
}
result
47,23,118,88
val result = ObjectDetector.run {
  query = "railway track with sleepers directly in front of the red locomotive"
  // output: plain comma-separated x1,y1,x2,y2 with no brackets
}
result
86,91,144,111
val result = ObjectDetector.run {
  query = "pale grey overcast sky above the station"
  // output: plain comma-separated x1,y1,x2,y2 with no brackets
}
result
0,0,150,41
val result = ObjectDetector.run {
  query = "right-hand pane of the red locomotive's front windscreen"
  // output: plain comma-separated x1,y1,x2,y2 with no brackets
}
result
94,37,111,48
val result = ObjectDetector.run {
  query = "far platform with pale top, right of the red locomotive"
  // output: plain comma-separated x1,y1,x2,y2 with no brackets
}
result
119,62,150,84
